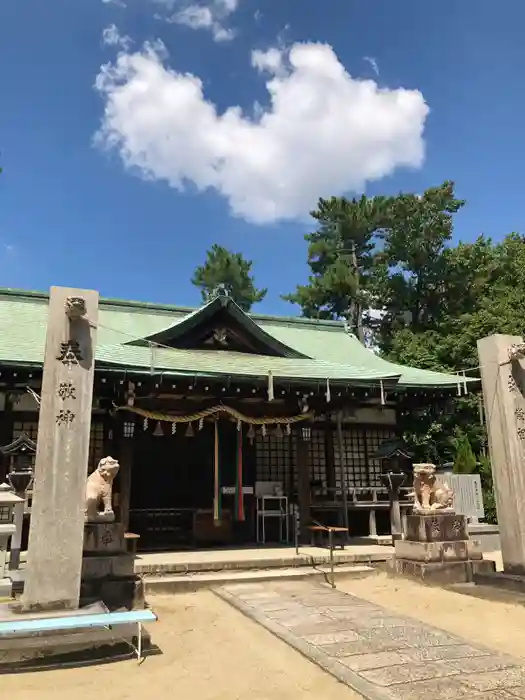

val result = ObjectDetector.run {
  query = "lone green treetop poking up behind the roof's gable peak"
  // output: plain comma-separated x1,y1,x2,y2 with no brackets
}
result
191,244,268,311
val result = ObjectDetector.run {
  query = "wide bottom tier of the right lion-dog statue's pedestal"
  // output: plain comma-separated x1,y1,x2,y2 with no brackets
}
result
392,557,495,585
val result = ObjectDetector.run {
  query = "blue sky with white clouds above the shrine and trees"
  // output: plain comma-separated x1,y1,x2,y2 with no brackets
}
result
0,0,525,313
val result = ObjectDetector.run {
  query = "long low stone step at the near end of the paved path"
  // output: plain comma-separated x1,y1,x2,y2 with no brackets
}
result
144,564,378,595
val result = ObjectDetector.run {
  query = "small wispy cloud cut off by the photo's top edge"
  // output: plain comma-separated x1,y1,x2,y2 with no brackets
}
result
161,0,239,42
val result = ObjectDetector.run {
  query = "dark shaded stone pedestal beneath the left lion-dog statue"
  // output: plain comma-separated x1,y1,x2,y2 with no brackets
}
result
80,523,144,610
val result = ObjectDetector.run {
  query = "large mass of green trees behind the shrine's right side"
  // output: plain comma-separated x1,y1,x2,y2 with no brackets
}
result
285,181,525,470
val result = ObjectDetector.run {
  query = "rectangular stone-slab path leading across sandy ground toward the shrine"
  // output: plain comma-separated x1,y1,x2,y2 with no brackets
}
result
216,582,525,700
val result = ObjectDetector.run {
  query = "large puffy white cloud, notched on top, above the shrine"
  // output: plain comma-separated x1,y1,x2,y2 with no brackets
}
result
96,42,429,223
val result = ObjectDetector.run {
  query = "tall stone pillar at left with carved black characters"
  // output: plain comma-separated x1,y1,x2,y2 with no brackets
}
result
20,287,98,611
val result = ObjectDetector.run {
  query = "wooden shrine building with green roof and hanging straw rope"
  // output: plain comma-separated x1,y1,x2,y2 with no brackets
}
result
0,289,467,550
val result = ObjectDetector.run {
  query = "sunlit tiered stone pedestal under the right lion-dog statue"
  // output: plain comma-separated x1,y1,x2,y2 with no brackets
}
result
394,513,494,583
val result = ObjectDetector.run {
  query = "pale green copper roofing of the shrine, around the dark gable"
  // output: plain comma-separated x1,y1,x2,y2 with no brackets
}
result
0,289,474,388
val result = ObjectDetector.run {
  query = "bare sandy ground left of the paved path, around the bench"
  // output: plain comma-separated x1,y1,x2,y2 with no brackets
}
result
4,591,360,700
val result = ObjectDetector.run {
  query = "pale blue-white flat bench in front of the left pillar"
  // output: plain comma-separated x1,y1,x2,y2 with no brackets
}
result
0,610,158,663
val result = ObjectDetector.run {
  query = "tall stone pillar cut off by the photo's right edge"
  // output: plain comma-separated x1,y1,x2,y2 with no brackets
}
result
478,334,525,575
